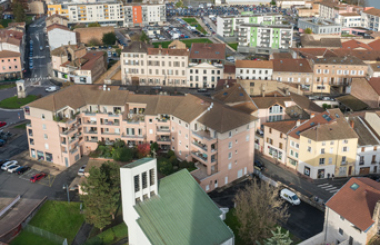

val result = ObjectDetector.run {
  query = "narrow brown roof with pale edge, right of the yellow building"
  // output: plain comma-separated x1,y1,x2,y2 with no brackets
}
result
350,116,380,146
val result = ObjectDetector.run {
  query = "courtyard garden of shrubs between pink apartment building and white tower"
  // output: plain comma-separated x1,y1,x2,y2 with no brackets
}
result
89,140,196,175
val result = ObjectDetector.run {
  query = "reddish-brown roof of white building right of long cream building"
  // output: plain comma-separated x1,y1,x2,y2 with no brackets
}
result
190,43,226,60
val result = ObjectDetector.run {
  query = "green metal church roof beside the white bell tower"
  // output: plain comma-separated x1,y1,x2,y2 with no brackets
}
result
135,169,234,245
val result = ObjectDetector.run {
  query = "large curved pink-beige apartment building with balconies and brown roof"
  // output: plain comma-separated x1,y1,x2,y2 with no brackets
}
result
24,85,257,191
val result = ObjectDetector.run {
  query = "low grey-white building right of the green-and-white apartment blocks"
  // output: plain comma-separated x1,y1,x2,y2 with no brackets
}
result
298,17,342,35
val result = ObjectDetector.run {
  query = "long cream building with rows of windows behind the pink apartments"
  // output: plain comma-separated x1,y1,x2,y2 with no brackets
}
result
121,42,189,87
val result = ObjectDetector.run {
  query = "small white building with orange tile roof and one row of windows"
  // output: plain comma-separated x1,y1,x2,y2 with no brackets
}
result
235,60,273,80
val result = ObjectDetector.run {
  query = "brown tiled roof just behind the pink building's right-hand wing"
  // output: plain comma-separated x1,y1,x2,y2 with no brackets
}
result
213,84,252,104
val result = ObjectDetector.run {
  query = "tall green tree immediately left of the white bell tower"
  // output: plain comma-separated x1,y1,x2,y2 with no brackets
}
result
80,167,111,230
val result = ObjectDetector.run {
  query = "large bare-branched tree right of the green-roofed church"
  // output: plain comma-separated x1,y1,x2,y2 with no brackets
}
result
234,181,289,244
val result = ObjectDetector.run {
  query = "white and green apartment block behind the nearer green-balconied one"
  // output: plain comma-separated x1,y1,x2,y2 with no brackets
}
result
216,14,282,37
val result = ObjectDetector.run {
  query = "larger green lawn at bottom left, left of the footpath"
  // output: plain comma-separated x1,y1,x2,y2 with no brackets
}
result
29,200,84,244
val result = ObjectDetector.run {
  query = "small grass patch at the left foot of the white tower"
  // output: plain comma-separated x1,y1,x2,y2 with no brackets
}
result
85,223,128,245
